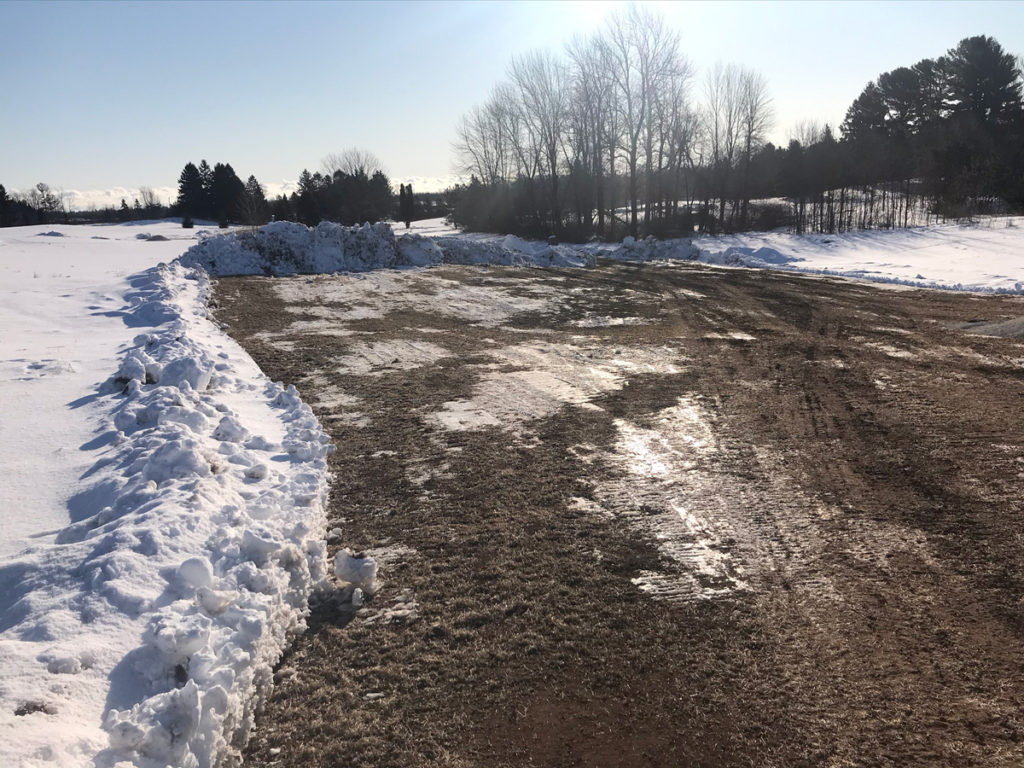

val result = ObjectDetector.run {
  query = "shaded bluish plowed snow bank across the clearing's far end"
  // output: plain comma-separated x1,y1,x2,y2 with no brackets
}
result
181,221,593,276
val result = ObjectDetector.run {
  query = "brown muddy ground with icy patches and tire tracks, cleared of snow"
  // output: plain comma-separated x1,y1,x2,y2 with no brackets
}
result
215,264,1024,768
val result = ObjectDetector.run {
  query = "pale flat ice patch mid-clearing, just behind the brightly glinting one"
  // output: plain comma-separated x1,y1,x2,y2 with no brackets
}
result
424,341,682,431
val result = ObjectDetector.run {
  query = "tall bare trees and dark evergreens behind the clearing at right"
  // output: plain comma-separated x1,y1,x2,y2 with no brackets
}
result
449,6,1024,240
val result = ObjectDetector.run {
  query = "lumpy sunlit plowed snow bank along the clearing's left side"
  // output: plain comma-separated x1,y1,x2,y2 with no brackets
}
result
0,260,332,768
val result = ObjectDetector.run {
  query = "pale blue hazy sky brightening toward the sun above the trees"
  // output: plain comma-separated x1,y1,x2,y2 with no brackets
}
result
0,0,1024,207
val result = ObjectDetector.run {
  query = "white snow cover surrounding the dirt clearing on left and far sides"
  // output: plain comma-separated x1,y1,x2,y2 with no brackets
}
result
0,218,1024,766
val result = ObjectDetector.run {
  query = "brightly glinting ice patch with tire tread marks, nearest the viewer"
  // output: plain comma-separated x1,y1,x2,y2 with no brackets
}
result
594,397,748,600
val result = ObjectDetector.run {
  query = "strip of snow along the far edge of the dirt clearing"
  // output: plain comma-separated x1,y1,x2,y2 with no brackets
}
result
185,217,1024,293
